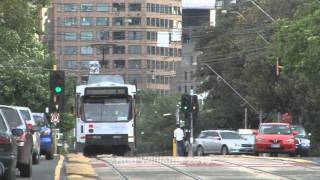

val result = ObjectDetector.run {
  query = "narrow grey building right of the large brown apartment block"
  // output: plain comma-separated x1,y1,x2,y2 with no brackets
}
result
172,0,216,94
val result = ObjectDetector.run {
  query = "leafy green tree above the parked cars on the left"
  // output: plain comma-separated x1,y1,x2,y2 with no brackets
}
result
0,0,51,112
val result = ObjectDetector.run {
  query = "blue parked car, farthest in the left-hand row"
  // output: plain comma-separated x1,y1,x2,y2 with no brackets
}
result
32,113,53,160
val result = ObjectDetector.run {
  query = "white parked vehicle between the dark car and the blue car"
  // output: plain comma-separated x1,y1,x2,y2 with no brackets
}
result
12,106,40,164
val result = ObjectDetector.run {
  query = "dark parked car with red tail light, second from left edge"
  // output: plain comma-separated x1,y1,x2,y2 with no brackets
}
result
0,105,34,177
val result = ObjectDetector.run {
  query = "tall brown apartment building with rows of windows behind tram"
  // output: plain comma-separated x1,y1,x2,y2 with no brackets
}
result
49,0,182,94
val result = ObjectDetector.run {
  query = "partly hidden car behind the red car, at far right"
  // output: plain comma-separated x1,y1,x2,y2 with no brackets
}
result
291,125,311,156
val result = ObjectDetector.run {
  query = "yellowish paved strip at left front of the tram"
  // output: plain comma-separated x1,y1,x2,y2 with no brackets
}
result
64,153,98,180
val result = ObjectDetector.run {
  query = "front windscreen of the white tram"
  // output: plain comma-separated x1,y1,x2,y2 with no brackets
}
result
84,99,130,121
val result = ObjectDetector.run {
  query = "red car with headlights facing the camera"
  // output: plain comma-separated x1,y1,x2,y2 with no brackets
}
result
255,123,297,156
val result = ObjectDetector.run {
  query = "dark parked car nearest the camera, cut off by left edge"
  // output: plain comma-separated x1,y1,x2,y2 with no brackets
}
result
0,110,23,180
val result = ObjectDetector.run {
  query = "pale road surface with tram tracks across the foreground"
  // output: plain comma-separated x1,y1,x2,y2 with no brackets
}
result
91,155,320,180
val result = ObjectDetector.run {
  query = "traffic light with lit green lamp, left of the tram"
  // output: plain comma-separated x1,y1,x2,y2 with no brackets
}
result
50,71,65,112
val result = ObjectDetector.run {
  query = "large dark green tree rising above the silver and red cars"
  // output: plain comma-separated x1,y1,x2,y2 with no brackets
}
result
194,0,304,129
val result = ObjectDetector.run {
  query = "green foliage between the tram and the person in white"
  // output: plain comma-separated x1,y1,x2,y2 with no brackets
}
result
137,91,180,153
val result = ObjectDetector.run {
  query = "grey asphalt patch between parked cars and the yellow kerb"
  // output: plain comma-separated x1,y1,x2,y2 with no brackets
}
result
16,156,59,180
